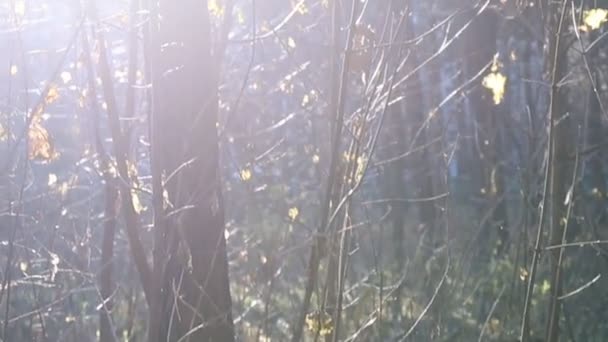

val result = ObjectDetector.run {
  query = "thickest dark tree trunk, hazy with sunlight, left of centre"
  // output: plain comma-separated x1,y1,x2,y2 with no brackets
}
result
149,0,234,342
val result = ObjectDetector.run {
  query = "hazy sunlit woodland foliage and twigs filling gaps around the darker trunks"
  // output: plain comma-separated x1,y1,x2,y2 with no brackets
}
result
0,0,608,341
